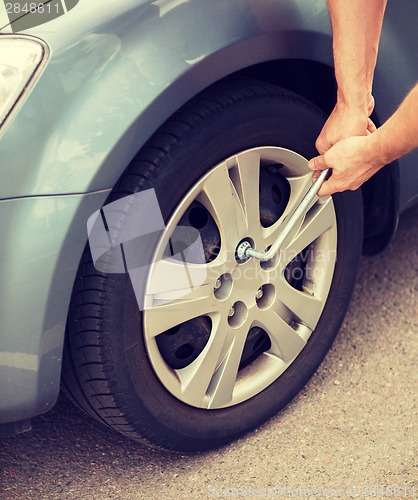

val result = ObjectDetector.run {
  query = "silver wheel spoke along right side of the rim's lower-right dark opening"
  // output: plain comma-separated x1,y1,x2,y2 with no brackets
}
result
255,309,306,362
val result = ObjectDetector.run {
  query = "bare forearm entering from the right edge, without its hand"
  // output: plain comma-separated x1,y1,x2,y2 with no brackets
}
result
368,84,418,165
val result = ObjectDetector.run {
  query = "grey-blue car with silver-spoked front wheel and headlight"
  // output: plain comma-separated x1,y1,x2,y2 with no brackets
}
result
0,0,418,451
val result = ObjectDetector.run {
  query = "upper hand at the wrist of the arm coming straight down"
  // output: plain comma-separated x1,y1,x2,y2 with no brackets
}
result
315,96,376,154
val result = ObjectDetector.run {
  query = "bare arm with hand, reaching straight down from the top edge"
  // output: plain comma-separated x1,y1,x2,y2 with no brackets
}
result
316,0,387,153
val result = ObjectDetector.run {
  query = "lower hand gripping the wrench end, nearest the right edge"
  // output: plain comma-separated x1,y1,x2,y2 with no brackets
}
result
308,134,383,196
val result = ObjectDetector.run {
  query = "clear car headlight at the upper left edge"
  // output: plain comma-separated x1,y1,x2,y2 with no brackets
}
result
0,35,49,132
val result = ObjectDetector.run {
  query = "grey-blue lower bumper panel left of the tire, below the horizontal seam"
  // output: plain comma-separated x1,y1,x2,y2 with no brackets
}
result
0,191,108,423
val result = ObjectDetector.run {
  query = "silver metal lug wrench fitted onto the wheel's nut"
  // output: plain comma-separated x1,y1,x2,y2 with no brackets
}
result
237,168,331,262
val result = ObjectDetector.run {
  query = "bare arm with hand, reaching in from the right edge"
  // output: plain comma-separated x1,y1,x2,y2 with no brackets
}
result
309,84,418,196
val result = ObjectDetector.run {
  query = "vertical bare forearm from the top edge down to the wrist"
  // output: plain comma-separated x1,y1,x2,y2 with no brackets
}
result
328,0,387,110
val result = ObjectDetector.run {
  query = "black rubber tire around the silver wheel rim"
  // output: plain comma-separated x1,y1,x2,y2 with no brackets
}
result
63,79,363,451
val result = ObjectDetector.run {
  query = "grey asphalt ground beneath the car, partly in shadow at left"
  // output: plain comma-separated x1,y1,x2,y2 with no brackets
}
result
0,207,418,500
